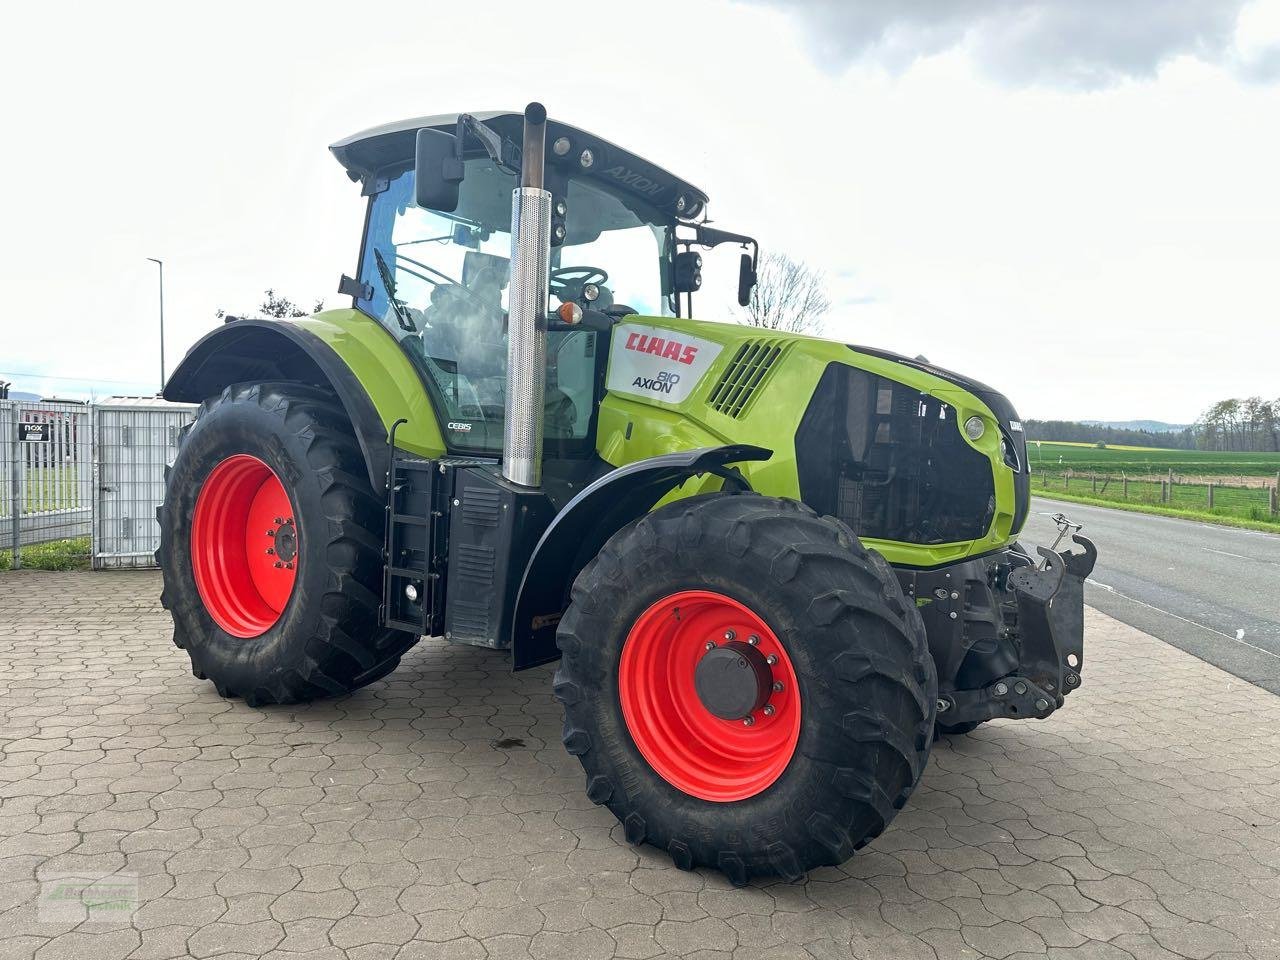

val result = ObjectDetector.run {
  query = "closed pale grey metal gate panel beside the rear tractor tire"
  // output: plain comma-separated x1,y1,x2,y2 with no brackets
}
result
93,397,196,570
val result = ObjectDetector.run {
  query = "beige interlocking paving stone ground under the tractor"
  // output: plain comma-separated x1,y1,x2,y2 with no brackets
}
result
0,571,1280,960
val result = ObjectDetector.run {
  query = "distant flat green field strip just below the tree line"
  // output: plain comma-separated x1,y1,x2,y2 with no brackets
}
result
1027,440,1280,477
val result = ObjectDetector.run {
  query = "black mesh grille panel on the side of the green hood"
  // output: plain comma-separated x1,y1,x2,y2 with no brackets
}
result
796,364,996,544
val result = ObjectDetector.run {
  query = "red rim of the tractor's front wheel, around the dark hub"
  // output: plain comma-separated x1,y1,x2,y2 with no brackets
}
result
618,590,800,803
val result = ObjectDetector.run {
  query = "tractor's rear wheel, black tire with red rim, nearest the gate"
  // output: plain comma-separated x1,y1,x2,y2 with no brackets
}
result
156,383,419,704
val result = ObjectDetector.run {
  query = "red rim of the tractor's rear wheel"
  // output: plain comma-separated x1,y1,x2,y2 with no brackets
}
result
191,453,298,639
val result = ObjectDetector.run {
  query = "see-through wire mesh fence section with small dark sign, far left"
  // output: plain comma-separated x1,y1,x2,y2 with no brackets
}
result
0,399,93,566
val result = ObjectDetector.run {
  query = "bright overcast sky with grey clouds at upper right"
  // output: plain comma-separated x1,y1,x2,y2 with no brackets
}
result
0,0,1280,421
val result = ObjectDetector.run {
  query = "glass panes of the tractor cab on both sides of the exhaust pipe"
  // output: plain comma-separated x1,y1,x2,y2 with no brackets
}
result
357,159,669,453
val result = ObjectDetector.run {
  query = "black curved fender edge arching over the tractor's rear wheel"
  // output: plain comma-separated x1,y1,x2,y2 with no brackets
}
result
164,320,390,490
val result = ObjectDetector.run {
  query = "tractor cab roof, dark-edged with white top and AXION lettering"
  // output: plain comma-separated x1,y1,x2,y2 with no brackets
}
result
329,110,707,221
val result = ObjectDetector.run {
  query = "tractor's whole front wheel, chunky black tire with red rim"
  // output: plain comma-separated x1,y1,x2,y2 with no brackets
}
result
556,494,937,884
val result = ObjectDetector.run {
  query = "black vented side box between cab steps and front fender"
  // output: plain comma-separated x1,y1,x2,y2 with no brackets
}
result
444,466,556,646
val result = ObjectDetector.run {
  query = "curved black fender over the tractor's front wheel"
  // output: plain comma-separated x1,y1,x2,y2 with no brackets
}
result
511,444,773,669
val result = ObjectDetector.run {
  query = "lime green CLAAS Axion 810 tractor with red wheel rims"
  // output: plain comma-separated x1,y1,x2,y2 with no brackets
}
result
157,104,1096,883
